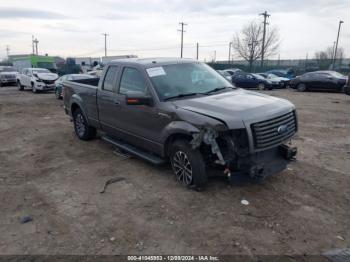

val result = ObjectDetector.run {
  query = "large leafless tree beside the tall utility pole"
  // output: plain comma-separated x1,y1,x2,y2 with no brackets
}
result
232,22,279,70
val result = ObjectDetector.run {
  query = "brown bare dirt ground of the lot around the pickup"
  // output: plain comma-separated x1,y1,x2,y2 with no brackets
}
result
0,87,350,255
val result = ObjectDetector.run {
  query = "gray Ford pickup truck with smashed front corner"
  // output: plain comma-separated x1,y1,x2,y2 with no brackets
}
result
63,58,298,188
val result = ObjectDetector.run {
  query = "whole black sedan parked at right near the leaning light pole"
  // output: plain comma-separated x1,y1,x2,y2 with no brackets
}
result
290,71,346,92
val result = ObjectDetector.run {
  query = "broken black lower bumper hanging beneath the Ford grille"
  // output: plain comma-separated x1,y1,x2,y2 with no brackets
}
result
230,145,297,182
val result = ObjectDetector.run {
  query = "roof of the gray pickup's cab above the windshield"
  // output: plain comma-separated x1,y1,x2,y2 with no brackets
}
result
108,57,198,68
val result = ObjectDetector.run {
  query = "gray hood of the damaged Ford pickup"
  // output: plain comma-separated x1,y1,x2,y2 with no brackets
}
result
173,89,295,129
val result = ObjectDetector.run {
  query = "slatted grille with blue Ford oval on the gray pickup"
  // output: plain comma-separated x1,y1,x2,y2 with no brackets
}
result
251,111,297,149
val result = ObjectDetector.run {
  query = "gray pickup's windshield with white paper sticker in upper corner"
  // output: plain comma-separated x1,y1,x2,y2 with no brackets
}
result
146,63,234,100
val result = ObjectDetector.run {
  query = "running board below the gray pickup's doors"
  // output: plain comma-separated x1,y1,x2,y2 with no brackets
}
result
101,136,165,165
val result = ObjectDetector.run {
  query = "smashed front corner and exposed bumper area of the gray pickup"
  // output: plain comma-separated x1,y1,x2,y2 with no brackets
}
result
191,126,297,179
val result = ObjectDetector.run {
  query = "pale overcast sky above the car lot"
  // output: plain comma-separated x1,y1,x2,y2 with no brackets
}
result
0,0,350,60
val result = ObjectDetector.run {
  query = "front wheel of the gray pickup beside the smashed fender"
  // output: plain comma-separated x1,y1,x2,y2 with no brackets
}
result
169,140,208,190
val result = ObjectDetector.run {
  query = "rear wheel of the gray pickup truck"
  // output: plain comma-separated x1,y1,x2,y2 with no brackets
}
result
73,108,96,141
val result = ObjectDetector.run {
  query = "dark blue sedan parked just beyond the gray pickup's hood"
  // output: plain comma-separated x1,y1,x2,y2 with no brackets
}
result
232,72,273,90
